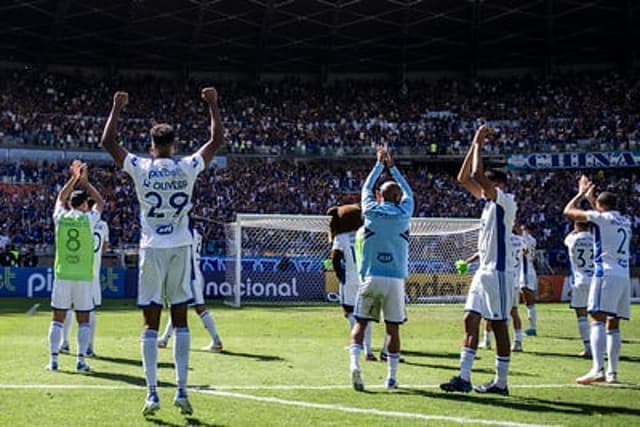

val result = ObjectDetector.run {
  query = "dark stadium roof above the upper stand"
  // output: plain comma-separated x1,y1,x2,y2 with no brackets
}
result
0,0,640,73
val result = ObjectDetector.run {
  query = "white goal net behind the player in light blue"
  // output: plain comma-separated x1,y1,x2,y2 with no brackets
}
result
222,214,480,307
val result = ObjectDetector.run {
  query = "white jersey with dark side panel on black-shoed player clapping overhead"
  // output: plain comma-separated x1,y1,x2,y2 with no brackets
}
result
478,188,517,272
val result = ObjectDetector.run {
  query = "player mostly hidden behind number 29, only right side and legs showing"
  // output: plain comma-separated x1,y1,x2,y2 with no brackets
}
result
158,229,223,352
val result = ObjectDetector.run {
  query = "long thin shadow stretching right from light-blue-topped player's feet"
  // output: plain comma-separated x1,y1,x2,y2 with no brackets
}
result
396,388,640,416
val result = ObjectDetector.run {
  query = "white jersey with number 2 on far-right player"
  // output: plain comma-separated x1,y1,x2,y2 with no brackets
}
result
587,211,631,277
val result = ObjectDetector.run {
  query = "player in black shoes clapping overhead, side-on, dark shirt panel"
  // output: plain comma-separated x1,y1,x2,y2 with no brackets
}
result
440,125,516,396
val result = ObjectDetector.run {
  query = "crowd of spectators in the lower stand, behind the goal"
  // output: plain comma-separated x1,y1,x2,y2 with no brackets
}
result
0,158,640,264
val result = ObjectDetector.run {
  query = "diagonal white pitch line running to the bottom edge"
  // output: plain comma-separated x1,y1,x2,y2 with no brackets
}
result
194,390,553,427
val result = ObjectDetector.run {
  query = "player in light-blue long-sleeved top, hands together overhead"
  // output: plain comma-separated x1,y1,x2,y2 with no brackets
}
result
349,148,414,391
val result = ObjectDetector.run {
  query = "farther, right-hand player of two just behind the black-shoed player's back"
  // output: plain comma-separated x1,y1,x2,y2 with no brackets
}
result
520,225,538,336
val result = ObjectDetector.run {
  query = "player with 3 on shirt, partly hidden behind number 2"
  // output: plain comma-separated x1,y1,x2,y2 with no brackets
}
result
564,221,593,359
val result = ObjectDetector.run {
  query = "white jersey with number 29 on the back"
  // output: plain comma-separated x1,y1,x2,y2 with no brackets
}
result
123,153,205,248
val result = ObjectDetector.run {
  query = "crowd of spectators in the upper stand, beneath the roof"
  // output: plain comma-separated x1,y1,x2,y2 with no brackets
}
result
0,69,640,156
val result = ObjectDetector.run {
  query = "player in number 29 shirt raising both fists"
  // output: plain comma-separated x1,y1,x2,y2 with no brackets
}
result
101,88,224,416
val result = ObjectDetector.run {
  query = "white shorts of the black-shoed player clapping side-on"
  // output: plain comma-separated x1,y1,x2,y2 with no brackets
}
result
464,270,514,320
